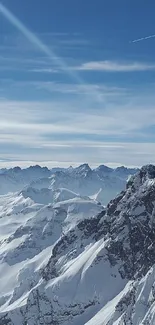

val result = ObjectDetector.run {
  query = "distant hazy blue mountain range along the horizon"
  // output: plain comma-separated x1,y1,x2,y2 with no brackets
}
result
0,164,137,204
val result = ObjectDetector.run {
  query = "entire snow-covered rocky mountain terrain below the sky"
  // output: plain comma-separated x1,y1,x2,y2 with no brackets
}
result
0,165,155,325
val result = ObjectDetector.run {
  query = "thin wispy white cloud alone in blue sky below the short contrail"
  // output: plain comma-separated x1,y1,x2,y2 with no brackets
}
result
74,60,155,72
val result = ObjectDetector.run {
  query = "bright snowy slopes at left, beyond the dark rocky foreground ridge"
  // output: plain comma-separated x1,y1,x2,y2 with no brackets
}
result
0,188,103,325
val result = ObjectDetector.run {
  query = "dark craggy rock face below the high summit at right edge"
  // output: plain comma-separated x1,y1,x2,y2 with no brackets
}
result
102,165,155,279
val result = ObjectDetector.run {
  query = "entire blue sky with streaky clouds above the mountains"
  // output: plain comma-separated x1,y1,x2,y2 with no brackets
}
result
0,0,155,167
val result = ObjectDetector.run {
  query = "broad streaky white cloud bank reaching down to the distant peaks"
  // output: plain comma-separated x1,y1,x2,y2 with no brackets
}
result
0,99,155,166
